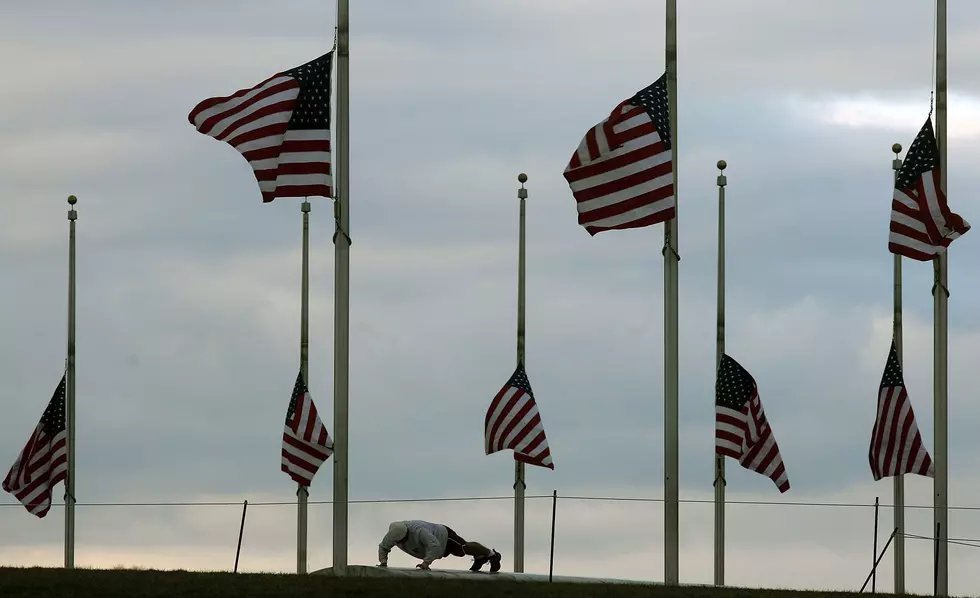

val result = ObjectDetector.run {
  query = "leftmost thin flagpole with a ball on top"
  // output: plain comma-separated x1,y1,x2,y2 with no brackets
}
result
65,195,78,569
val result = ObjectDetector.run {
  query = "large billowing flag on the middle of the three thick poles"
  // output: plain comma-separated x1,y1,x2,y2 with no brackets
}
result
564,73,676,235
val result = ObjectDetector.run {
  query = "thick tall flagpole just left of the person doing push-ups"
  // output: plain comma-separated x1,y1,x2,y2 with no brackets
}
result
333,0,350,575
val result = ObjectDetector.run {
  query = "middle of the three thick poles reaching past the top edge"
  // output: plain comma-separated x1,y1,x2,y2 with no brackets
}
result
664,0,680,585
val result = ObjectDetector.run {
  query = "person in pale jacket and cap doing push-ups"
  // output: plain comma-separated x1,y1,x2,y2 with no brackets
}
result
378,519,500,573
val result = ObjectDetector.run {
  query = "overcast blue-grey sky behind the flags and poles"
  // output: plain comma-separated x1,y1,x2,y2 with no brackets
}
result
0,0,980,593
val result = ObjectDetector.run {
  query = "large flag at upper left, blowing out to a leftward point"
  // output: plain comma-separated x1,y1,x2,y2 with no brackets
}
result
187,51,333,202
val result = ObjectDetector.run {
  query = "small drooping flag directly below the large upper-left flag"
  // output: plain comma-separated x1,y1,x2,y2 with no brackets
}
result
282,372,333,487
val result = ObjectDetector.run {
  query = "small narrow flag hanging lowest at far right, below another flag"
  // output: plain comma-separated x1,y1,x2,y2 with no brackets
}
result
868,339,935,481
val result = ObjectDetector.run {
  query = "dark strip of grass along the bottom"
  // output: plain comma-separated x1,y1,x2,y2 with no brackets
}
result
0,568,920,598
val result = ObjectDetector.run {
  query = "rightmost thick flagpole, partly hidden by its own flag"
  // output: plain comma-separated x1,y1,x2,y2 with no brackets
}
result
933,0,949,596
